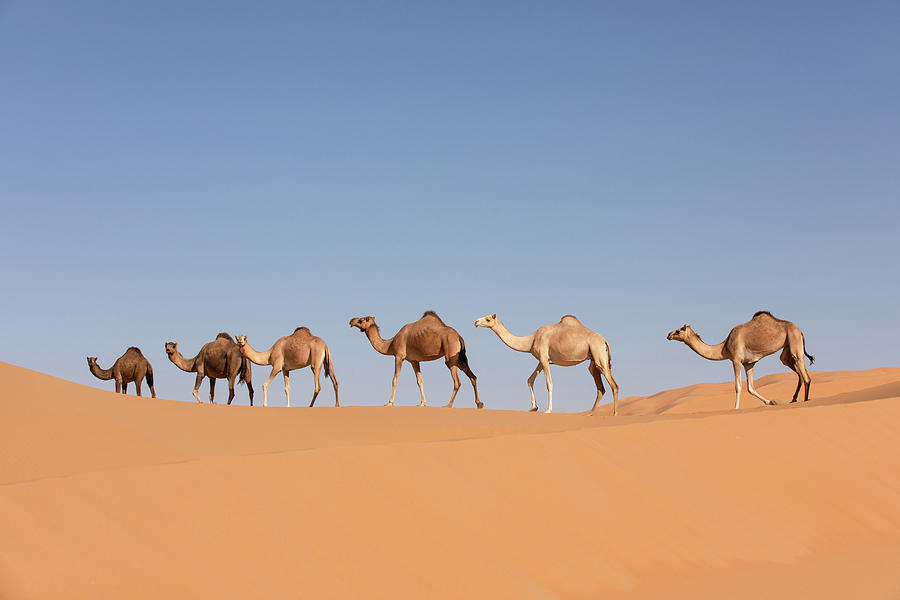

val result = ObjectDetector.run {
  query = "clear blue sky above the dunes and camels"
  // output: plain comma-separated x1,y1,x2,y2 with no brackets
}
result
0,0,900,411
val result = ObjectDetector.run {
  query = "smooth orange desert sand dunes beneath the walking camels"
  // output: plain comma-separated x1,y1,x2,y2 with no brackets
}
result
0,363,900,599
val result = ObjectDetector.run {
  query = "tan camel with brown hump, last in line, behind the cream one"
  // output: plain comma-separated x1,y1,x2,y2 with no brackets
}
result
666,310,816,409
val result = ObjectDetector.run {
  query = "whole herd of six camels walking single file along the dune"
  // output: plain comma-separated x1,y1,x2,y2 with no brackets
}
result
87,311,815,415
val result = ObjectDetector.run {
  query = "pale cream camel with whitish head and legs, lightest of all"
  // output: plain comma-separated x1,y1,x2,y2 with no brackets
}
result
475,313,619,415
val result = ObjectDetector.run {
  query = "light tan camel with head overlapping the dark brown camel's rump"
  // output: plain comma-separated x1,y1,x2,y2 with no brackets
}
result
237,327,341,408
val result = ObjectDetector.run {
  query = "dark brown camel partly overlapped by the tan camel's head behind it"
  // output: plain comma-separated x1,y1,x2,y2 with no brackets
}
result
166,332,253,406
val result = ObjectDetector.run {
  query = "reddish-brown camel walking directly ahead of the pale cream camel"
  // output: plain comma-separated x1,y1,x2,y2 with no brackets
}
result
350,310,484,408
